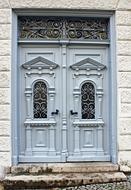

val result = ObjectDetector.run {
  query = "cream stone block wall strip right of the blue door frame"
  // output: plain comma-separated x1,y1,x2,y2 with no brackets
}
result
116,0,131,171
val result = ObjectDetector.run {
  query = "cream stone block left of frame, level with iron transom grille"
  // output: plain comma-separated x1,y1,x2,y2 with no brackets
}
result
0,24,11,40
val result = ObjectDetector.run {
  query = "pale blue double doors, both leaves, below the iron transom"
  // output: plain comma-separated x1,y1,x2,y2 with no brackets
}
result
18,44,110,162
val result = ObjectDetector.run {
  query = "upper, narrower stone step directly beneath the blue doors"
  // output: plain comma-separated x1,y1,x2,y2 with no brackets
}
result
9,162,119,175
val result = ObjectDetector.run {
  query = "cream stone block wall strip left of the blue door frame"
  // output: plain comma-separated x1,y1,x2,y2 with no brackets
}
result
0,1,11,165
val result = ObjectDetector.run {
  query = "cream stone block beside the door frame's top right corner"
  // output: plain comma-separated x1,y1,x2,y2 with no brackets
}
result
116,11,131,26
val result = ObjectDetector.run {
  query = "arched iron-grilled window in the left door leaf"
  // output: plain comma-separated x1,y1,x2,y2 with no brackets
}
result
33,81,47,119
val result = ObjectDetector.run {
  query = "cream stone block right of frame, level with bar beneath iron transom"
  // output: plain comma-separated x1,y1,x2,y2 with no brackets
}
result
117,41,131,56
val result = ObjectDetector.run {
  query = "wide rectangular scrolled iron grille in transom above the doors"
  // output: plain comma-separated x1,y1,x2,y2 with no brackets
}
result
18,16,109,40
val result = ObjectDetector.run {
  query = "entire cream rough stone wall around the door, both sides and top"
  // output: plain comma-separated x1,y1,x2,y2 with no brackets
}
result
0,0,131,170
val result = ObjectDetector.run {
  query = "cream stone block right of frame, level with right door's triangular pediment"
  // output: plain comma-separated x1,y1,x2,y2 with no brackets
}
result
117,56,131,71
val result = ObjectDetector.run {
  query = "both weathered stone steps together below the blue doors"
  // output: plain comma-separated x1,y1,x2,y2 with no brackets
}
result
0,162,127,190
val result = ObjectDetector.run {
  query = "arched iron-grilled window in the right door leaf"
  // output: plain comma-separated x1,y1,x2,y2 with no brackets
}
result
81,82,95,119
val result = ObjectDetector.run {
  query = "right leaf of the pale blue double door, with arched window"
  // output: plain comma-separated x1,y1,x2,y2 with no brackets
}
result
67,46,110,161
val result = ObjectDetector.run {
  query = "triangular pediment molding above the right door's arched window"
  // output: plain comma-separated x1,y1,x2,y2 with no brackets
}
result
70,57,106,70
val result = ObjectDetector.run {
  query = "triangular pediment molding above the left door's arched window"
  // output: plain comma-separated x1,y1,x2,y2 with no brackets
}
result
22,56,58,70
